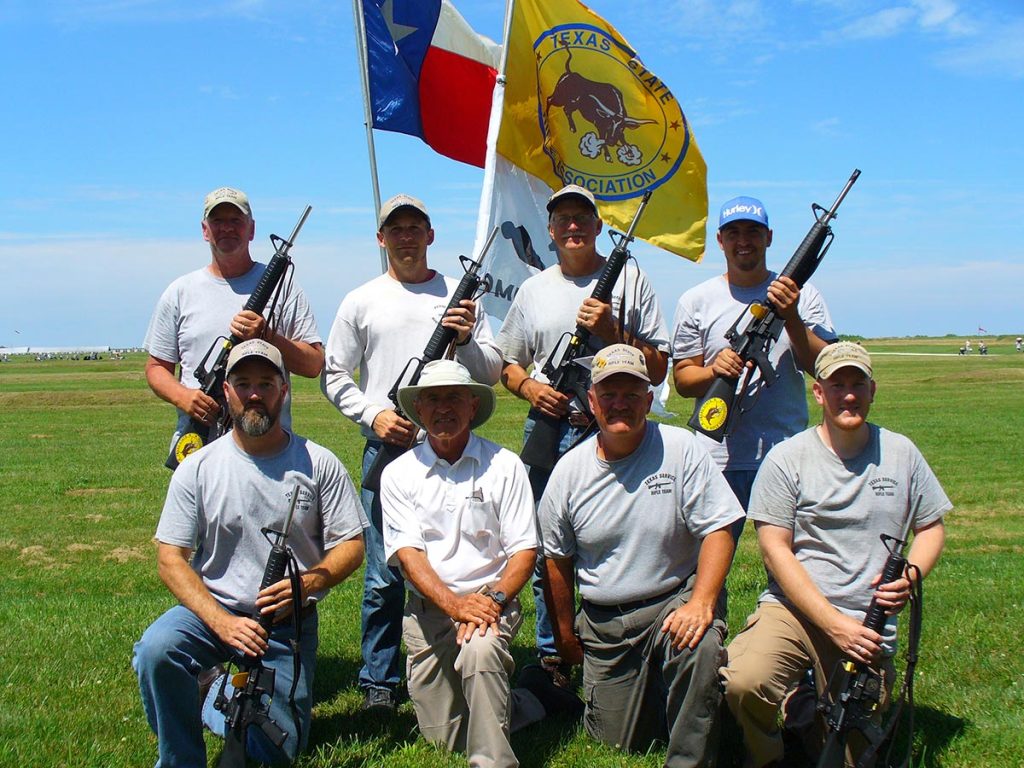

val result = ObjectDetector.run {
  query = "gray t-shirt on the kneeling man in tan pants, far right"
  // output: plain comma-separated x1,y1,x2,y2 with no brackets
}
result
748,424,952,647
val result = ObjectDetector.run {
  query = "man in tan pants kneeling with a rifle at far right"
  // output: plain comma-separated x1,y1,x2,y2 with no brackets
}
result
722,341,952,768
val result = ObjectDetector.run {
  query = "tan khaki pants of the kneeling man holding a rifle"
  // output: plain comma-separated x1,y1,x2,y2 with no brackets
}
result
721,602,895,766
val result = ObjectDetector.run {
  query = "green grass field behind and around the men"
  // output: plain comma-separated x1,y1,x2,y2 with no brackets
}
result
0,339,1024,768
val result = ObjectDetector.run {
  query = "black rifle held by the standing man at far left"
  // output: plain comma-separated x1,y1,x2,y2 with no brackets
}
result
164,206,312,472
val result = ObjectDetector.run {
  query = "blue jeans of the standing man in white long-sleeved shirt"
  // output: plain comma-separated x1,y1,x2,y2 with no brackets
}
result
359,440,406,691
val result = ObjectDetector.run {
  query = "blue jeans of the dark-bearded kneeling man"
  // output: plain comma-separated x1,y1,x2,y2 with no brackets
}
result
131,605,317,768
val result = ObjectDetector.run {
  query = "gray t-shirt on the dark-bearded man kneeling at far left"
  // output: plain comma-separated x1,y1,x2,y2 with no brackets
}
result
157,434,369,613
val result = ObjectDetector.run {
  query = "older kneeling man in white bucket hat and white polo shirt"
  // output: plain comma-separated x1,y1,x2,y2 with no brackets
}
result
380,359,543,767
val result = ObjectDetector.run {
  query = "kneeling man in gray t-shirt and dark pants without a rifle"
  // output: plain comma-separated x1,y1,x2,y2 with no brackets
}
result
539,344,743,768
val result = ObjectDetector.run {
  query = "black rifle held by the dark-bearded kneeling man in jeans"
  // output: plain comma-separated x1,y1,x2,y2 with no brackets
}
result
213,484,302,768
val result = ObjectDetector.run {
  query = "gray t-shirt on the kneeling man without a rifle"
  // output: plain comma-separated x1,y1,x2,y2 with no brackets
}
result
538,421,743,605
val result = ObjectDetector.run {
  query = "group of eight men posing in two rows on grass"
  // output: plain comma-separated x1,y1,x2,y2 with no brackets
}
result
133,186,950,767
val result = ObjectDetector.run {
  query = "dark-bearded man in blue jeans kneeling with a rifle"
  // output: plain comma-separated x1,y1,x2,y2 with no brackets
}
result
132,339,368,768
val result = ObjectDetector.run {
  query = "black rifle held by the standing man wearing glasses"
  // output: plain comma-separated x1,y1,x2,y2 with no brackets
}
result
519,189,651,470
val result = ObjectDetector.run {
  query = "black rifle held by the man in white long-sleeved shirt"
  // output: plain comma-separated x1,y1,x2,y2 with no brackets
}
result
362,227,498,494
